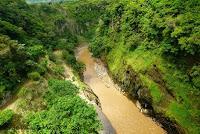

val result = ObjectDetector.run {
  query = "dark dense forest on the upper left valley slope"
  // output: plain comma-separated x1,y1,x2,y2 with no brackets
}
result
0,0,77,103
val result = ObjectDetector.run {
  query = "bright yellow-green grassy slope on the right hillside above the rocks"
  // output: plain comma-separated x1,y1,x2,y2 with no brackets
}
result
107,44,200,134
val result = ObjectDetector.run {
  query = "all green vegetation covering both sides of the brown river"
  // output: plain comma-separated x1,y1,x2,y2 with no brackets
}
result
0,0,200,134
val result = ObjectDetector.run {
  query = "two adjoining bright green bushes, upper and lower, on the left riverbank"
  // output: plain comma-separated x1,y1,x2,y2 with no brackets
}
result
26,80,100,134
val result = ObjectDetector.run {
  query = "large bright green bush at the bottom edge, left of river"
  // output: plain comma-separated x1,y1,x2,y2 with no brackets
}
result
26,97,100,134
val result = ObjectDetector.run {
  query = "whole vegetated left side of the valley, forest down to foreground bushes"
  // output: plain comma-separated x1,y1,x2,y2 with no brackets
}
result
0,0,101,133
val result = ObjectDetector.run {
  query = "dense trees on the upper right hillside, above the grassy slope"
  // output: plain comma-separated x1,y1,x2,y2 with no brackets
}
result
92,0,200,56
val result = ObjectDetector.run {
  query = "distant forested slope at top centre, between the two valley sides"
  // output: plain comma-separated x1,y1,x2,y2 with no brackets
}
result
68,0,108,38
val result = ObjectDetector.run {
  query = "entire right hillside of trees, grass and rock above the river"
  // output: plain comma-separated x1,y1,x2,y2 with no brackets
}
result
90,0,200,134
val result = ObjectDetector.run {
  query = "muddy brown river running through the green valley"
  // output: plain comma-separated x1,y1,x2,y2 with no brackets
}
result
77,45,165,134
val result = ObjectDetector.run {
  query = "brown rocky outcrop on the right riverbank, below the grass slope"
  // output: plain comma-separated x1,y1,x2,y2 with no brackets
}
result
113,65,152,109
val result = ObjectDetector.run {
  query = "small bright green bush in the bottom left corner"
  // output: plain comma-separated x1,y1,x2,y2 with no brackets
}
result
0,110,14,127
